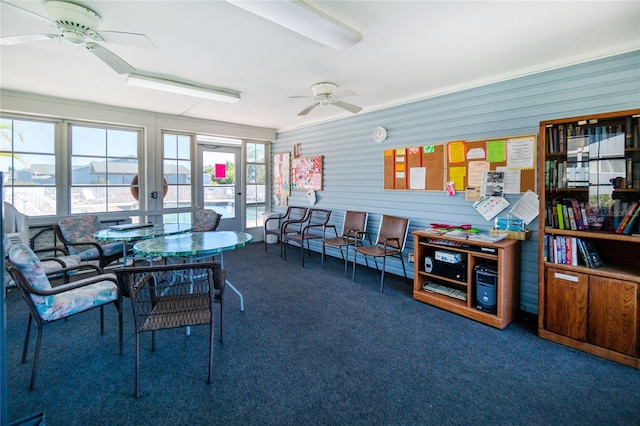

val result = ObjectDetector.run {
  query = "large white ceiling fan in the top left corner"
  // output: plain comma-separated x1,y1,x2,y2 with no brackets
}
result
0,0,155,74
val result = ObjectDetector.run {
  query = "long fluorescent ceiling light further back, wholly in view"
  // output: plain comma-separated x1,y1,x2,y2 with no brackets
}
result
127,73,240,103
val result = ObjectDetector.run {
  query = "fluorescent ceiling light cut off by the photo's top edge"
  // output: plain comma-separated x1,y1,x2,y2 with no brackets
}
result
227,0,362,50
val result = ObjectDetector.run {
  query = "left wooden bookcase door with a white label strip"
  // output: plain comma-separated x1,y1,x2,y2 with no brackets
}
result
545,268,589,341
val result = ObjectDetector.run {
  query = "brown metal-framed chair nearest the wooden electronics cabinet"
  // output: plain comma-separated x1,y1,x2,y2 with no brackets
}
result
352,214,409,293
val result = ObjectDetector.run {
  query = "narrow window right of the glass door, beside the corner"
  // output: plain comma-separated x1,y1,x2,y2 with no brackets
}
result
245,142,267,228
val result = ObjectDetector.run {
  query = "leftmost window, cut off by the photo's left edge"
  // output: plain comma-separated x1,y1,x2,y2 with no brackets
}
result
0,118,56,216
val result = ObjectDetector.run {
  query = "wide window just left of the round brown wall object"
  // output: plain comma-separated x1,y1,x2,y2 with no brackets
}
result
70,125,140,213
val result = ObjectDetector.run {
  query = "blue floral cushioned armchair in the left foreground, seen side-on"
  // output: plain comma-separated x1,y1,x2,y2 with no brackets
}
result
6,244,122,389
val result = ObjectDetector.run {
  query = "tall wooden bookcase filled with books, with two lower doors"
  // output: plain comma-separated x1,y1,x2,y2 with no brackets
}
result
538,110,640,368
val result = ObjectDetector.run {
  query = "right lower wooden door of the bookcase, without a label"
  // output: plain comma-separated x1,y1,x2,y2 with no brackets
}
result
589,276,639,356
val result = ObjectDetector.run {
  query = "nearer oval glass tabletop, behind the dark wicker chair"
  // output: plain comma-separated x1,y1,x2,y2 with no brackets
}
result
133,231,253,257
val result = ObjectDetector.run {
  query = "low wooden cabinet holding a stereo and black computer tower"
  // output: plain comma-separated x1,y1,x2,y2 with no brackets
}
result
413,231,520,329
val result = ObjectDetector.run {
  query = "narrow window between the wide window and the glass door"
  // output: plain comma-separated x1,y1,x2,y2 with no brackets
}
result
162,133,191,211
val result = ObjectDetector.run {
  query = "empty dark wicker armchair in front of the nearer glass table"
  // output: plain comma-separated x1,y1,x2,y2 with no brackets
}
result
116,262,225,398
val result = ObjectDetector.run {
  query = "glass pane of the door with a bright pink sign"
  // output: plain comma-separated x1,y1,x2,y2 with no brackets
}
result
198,144,244,231
